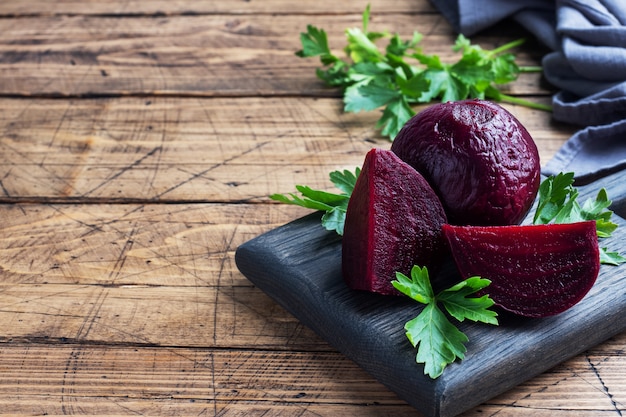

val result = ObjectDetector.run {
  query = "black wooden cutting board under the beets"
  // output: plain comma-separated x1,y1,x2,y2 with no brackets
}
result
236,172,626,417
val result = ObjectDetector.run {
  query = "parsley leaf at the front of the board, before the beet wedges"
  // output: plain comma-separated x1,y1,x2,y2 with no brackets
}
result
391,266,498,379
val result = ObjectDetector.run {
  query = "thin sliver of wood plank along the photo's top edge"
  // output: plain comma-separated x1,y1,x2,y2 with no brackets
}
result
0,0,435,17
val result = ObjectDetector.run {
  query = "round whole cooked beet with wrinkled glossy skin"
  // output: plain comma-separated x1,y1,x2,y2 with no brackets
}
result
391,100,540,225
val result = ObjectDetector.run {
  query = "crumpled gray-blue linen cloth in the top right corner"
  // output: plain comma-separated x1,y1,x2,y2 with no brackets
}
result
430,0,626,184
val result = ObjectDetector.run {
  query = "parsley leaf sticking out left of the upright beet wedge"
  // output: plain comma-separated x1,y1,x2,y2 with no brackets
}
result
270,168,361,235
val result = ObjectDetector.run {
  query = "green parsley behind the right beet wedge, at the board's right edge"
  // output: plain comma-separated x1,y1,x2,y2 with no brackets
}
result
533,172,626,265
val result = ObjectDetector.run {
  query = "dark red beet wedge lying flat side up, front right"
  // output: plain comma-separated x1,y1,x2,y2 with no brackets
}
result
443,221,600,317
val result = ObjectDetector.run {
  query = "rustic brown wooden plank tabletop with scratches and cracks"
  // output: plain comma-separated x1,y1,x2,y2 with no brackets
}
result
0,0,626,417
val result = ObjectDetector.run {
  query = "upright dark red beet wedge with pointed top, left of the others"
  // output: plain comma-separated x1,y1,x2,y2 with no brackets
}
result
342,149,446,295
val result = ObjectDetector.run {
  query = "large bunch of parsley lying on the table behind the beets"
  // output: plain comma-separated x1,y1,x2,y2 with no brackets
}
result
296,5,551,140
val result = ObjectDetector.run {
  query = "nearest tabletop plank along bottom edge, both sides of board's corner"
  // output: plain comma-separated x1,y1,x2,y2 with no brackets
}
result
0,335,626,417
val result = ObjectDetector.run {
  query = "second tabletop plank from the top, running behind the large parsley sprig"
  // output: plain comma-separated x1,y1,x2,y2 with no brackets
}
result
0,13,550,96
